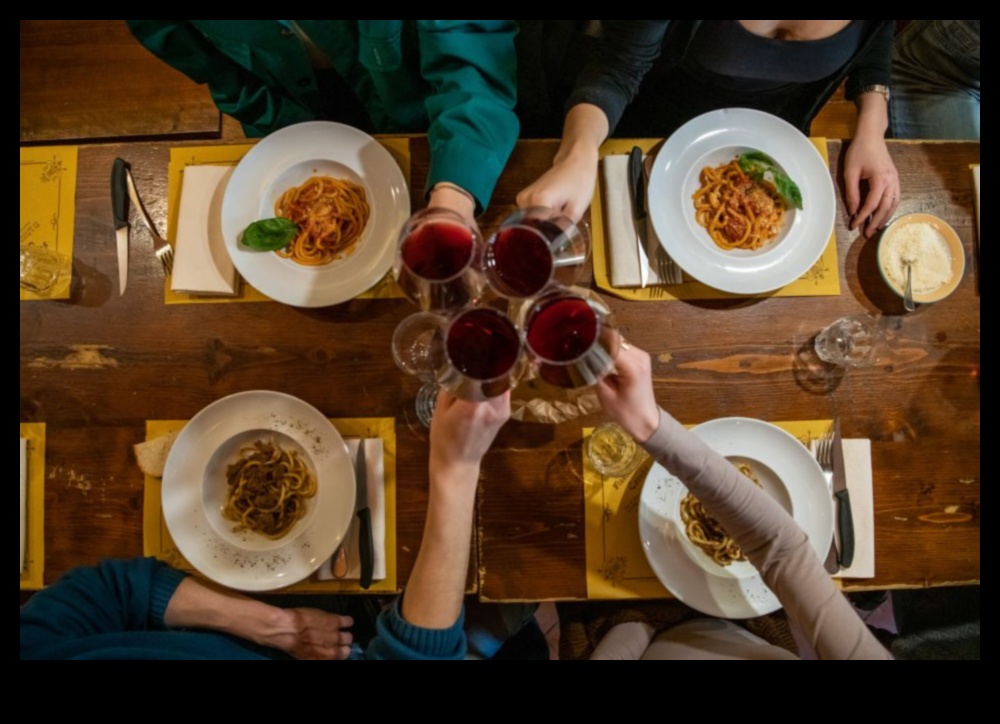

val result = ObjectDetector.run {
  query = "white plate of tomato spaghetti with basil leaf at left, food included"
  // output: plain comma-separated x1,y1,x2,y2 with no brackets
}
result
222,121,410,307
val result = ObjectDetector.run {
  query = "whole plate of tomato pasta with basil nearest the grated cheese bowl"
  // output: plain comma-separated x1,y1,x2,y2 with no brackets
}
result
648,109,836,295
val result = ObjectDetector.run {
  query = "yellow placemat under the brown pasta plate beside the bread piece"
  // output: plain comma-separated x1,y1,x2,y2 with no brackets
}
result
144,418,398,594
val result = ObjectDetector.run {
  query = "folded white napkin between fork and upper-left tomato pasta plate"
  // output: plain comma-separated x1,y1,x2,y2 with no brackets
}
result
170,166,237,296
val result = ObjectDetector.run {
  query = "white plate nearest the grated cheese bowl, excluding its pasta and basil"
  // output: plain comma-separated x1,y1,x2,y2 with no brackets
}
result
649,108,836,294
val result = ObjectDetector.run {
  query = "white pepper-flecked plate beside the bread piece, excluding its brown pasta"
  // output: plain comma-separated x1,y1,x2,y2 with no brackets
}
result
162,391,356,592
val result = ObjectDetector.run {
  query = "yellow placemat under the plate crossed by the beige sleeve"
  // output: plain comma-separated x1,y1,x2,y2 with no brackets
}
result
583,420,833,600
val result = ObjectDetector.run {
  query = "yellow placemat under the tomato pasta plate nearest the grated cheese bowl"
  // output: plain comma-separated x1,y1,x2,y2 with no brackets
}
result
590,138,840,301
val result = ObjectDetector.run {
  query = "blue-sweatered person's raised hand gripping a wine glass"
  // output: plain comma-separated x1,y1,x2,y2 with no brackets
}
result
431,391,510,479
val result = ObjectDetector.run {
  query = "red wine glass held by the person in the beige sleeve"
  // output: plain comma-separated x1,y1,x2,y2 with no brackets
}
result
523,289,621,389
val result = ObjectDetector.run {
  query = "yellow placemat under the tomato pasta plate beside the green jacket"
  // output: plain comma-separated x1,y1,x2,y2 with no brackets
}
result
164,137,410,304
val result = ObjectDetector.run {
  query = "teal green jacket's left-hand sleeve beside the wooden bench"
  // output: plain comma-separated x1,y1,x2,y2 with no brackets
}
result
125,20,316,138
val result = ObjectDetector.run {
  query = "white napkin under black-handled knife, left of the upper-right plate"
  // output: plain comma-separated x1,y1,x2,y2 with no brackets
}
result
601,155,661,289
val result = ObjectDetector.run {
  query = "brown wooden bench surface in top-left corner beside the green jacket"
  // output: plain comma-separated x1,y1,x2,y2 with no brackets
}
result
20,20,221,143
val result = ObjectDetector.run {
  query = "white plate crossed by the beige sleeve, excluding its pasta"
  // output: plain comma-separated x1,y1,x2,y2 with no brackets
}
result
639,417,833,619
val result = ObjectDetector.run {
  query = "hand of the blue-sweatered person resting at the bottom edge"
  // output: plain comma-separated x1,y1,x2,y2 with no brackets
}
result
257,608,354,661
